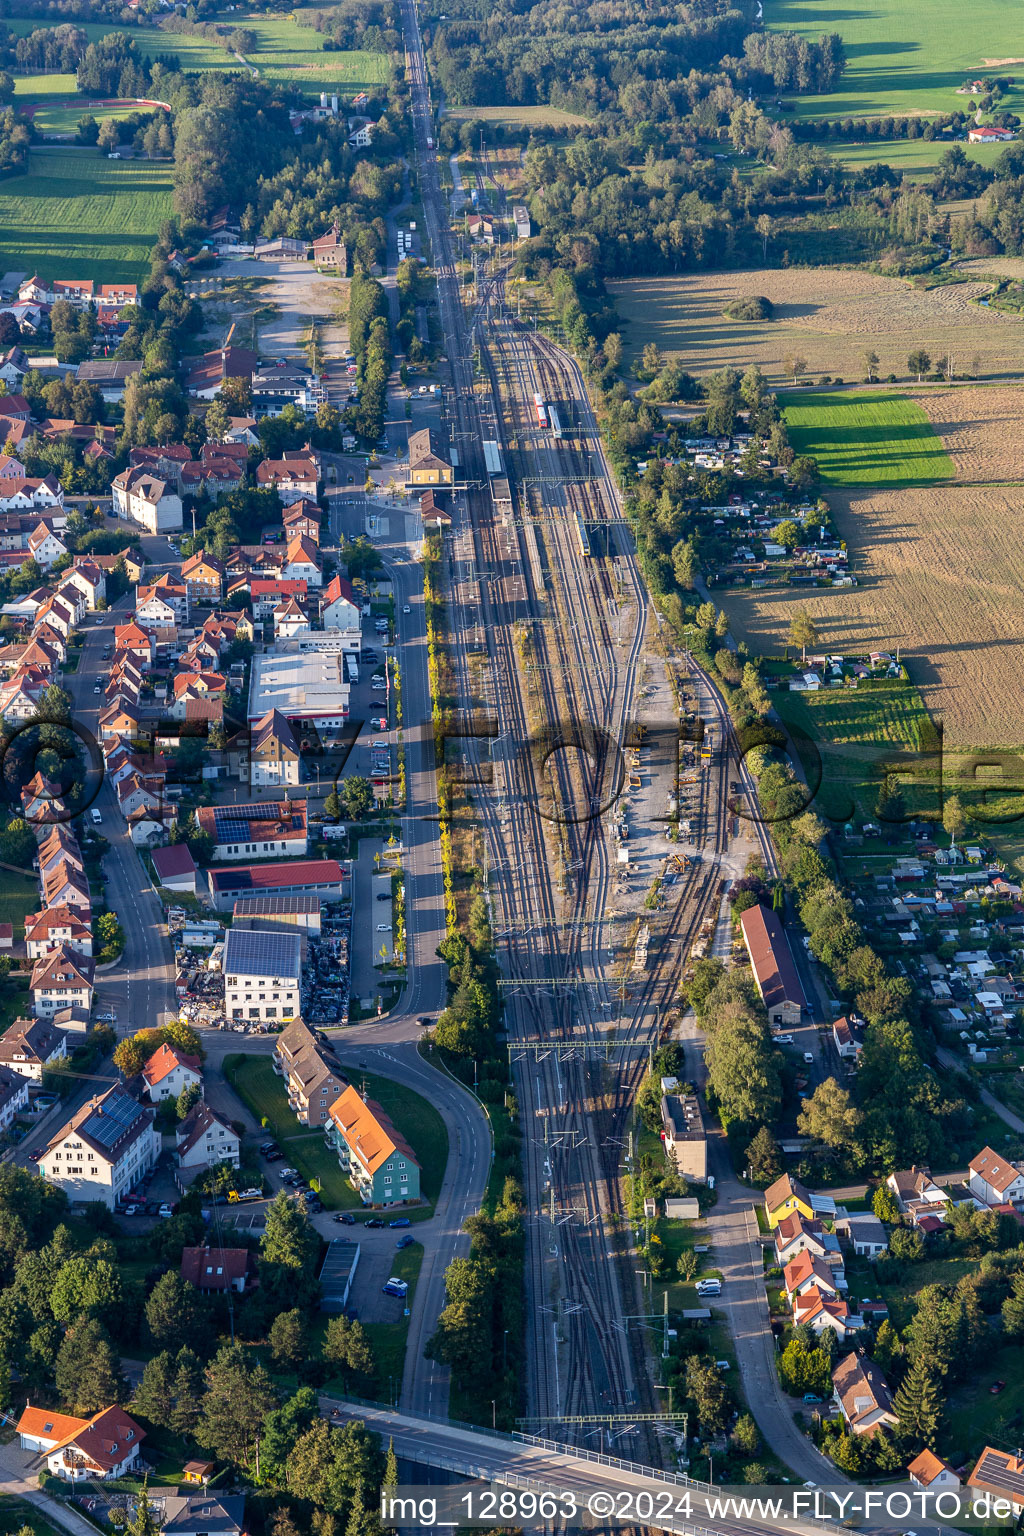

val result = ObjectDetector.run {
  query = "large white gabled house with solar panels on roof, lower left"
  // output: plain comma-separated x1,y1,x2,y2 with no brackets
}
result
37,1083,161,1210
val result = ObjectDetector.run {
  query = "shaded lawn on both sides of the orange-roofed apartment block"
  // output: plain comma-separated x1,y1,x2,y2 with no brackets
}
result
224,1055,448,1221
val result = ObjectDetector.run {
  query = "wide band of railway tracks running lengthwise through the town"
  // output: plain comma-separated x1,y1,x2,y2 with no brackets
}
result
402,0,746,1459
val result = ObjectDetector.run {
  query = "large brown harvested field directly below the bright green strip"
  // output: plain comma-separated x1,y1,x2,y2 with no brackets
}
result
718,484,1024,748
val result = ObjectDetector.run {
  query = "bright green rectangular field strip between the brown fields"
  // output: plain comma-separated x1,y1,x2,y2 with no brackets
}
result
785,390,956,487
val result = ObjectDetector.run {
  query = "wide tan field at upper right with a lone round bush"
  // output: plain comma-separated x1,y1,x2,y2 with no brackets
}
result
608,267,1024,384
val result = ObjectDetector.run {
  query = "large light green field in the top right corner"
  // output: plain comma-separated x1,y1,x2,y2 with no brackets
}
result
765,0,1024,117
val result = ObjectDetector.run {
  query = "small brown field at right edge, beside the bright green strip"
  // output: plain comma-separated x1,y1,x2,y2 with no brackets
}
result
907,384,1024,484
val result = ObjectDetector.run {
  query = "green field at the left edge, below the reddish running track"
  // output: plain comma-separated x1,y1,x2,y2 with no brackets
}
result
0,147,172,283
